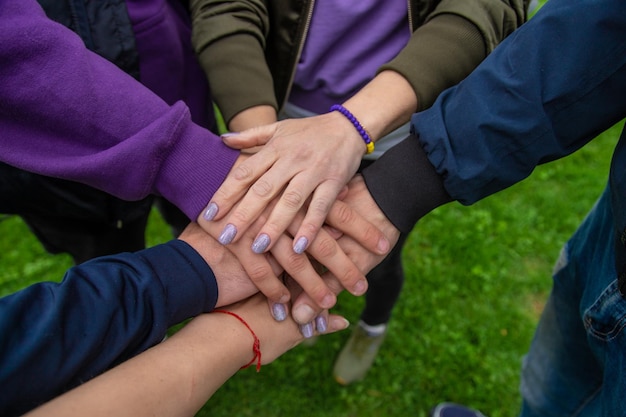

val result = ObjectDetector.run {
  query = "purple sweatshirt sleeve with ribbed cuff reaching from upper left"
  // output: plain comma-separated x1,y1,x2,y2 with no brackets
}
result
0,0,239,219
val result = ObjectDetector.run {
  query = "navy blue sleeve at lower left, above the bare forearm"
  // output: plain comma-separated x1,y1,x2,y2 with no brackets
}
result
0,240,217,416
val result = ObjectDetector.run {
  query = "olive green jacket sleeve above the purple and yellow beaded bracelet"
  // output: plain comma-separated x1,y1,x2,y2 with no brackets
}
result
381,0,529,110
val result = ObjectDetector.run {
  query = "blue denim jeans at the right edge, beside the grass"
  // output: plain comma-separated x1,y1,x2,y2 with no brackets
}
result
520,189,626,417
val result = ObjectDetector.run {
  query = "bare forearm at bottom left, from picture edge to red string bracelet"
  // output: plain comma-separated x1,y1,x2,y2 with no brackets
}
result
23,314,253,417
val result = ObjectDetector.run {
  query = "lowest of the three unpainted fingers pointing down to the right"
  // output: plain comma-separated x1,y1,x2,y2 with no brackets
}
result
268,235,337,309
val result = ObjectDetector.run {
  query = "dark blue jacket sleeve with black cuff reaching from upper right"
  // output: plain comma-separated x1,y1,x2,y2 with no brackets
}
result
365,0,626,229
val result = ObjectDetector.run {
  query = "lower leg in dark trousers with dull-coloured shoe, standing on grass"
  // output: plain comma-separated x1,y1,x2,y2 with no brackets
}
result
333,234,407,385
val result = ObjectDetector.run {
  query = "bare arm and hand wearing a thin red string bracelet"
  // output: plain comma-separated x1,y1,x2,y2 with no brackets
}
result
22,294,348,417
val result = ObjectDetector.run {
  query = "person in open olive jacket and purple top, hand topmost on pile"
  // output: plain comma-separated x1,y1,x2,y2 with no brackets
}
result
191,0,527,260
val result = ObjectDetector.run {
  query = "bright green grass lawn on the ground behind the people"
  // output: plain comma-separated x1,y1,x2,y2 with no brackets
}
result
0,118,622,417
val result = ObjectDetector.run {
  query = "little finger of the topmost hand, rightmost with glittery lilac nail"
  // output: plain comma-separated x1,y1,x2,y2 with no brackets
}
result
290,181,343,253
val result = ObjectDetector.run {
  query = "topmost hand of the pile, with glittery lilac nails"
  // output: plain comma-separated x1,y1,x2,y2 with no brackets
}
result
202,112,365,253
